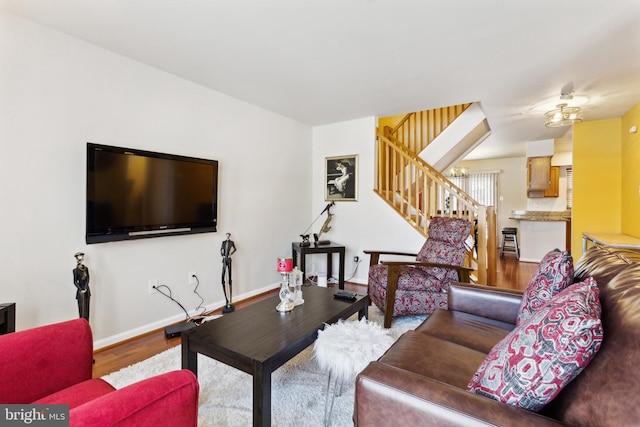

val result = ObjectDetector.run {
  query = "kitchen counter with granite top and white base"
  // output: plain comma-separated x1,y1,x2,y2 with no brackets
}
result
509,211,571,262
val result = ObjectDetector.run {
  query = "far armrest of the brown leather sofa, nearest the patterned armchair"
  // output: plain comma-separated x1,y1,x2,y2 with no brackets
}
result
448,283,523,325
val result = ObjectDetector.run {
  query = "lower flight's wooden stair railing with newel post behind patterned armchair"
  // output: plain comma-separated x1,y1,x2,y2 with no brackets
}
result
374,131,496,285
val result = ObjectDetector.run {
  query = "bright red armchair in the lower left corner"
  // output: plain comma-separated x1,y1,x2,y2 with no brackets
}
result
0,318,199,427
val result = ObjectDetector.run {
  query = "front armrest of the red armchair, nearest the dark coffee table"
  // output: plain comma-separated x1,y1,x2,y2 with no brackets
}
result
69,369,199,427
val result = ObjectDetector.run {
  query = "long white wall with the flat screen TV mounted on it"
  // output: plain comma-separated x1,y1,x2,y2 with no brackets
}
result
0,13,310,346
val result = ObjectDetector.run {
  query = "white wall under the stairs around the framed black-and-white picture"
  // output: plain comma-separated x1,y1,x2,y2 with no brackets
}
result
310,117,424,283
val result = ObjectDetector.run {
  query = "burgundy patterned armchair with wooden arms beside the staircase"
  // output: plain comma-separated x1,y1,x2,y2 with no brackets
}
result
364,217,471,328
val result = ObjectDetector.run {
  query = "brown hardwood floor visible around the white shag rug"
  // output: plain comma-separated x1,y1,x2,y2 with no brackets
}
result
93,255,538,378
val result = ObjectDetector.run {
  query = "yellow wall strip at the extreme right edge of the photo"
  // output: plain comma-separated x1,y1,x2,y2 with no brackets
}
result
620,104,640,237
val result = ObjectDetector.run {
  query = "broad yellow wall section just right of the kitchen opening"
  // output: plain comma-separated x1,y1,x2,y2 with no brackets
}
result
571,118,622,260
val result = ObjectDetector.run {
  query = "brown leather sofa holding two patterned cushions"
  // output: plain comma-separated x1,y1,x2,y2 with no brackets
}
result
354,246,640,427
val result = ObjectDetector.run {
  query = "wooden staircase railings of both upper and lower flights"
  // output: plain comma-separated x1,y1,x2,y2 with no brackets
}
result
374,104,496,285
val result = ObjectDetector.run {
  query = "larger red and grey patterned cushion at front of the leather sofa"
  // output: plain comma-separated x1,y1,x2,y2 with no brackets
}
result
467,278,603,411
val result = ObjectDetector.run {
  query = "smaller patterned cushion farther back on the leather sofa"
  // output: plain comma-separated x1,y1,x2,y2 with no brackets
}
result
516,249,573,324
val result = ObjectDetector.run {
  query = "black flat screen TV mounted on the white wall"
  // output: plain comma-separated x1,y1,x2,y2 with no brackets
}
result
86,143,218,244
